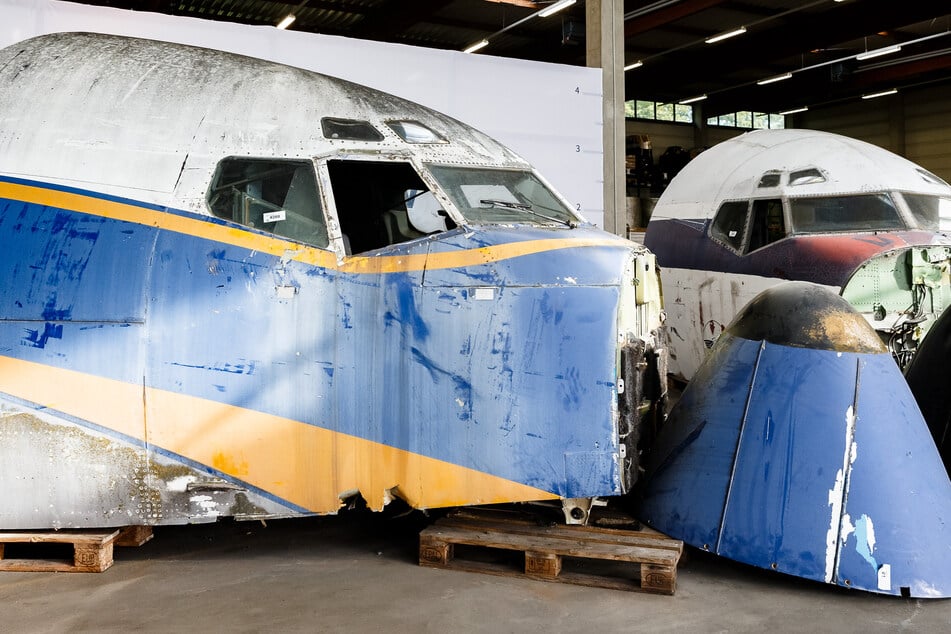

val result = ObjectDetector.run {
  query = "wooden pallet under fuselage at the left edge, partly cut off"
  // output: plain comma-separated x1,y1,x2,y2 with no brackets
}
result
0,526,152,572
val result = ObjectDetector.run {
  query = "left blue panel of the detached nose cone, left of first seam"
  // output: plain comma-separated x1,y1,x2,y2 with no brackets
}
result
640,333,760,550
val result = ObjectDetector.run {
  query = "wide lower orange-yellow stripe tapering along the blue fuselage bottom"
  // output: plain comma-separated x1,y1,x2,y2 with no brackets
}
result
0,356,558,513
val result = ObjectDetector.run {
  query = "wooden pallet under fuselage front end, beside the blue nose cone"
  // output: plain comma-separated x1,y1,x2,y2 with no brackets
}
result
419,509,683,595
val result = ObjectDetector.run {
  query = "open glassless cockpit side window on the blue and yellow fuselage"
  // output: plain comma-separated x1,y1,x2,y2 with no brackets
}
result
327,159,455,253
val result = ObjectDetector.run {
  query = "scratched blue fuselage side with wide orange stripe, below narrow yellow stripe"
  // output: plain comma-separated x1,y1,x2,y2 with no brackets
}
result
0,177,632,526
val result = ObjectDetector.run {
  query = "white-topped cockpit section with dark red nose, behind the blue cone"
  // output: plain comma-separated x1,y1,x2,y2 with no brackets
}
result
644,130,951,380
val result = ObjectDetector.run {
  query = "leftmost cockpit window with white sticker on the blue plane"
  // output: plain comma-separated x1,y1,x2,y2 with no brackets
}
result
207,158,328,247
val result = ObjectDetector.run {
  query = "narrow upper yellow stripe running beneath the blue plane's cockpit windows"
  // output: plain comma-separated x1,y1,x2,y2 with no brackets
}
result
0,182,625,274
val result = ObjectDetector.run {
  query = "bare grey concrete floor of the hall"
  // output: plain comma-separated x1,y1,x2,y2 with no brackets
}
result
0,511,951,634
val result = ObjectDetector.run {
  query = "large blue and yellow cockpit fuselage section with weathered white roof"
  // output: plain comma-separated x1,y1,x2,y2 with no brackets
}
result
0,34,666,529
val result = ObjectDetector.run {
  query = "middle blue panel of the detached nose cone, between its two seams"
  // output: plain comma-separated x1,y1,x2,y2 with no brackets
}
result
718,343,856,581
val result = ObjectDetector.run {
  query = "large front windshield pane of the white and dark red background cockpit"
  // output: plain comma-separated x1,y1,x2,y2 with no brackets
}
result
789,194,905,233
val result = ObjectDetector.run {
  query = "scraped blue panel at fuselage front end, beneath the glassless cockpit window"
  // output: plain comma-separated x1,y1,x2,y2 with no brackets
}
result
335,260,620,496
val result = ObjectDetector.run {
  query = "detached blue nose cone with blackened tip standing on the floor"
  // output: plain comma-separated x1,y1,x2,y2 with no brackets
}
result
640,282,951,597
